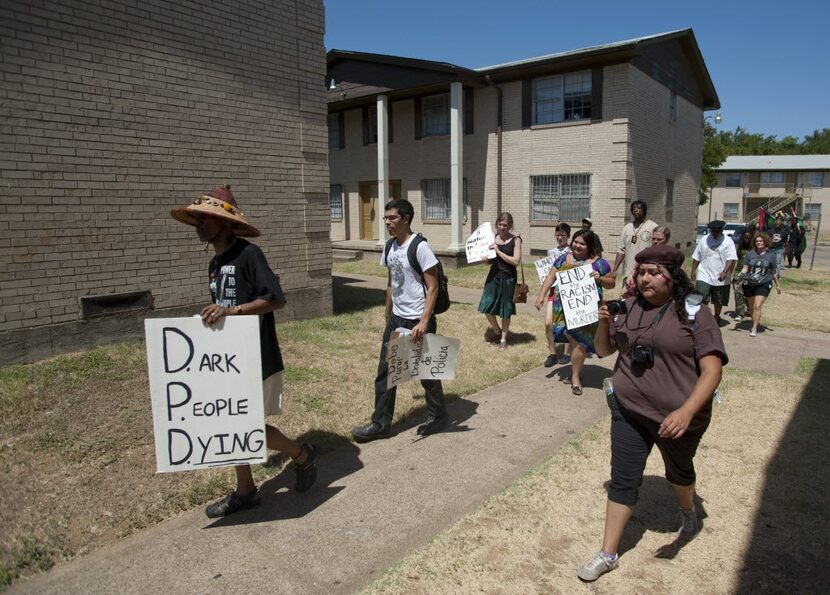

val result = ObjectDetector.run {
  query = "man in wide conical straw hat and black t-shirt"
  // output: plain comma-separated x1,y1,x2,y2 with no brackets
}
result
170,186,317,518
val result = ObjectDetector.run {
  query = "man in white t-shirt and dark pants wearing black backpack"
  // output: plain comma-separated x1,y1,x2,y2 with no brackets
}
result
352,199,447,442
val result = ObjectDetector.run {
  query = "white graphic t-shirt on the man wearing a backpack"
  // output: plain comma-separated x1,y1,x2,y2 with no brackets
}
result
380,234,438,320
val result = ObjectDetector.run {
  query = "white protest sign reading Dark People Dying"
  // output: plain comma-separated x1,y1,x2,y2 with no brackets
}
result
144,316,266,473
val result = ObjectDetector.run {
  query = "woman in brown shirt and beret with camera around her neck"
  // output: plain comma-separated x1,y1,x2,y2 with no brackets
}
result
577,245,727,581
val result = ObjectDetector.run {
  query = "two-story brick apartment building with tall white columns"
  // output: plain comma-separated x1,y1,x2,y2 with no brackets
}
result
327,29,720,262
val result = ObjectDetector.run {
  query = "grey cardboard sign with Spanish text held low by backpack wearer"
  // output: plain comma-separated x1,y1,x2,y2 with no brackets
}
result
386,329,461,388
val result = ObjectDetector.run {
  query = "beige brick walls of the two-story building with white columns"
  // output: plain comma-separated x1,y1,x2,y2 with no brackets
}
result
329,64,702,261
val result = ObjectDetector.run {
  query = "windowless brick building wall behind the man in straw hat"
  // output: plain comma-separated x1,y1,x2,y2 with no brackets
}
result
0,0,331,362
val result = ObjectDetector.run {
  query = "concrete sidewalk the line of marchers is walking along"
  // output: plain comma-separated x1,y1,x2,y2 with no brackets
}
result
12,275,830,593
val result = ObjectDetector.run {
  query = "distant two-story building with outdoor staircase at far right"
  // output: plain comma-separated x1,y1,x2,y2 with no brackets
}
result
697,155,830,223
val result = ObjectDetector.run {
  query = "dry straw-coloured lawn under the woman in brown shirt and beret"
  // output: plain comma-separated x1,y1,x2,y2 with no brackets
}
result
366,360,830,594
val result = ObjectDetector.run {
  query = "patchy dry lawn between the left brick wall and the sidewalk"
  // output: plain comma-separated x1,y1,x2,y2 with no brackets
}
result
0,286,544,587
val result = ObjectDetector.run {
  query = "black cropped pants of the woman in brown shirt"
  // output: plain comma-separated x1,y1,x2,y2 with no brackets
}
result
606,395,708,506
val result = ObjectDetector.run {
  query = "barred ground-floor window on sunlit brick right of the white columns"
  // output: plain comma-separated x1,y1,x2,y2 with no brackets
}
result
530,173,591,221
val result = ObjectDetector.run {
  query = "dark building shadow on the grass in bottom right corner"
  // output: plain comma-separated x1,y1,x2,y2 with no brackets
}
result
735,359,830,594
